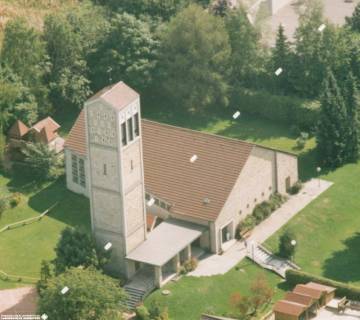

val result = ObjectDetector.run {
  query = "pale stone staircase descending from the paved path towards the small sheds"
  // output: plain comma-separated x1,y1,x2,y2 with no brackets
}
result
247,243,300,278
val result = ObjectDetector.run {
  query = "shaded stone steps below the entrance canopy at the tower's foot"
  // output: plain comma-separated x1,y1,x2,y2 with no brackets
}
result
124,267,155,310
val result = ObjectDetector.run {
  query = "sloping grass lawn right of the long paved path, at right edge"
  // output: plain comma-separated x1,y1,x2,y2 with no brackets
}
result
267,164,360,286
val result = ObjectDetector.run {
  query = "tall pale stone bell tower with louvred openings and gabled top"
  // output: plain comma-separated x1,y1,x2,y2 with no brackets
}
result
85,82,146,277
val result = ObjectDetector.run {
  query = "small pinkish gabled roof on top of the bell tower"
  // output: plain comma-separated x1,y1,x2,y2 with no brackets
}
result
86,81,139,110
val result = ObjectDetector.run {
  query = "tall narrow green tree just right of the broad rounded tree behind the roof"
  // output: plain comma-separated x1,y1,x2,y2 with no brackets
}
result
225,7,263,87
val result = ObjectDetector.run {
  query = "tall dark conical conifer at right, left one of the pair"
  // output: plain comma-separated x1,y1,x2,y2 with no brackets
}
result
316,71,349,168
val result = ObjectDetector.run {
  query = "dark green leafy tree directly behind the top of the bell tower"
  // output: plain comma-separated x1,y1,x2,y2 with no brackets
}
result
90,13,158,90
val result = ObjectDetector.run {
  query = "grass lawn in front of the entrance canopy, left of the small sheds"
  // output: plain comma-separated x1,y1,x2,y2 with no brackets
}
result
145,260,286,320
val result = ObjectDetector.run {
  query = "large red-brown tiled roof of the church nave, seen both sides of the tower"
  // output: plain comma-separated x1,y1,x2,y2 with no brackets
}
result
65,111,254,221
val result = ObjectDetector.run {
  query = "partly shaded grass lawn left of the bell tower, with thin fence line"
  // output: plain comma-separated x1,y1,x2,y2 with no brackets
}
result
0,175,90,288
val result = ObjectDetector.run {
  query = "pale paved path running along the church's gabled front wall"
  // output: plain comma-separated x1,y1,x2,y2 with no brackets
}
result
188,179,332,277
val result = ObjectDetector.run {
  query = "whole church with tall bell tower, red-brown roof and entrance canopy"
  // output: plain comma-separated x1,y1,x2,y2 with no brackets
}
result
65,82,298,287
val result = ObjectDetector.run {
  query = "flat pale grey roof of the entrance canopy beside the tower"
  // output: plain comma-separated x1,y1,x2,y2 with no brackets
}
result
126,219,206,267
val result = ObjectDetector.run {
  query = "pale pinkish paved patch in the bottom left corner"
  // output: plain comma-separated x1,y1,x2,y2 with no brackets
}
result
0,287,37,315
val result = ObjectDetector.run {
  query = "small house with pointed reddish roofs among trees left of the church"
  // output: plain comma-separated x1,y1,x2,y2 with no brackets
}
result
8,117,65,153
